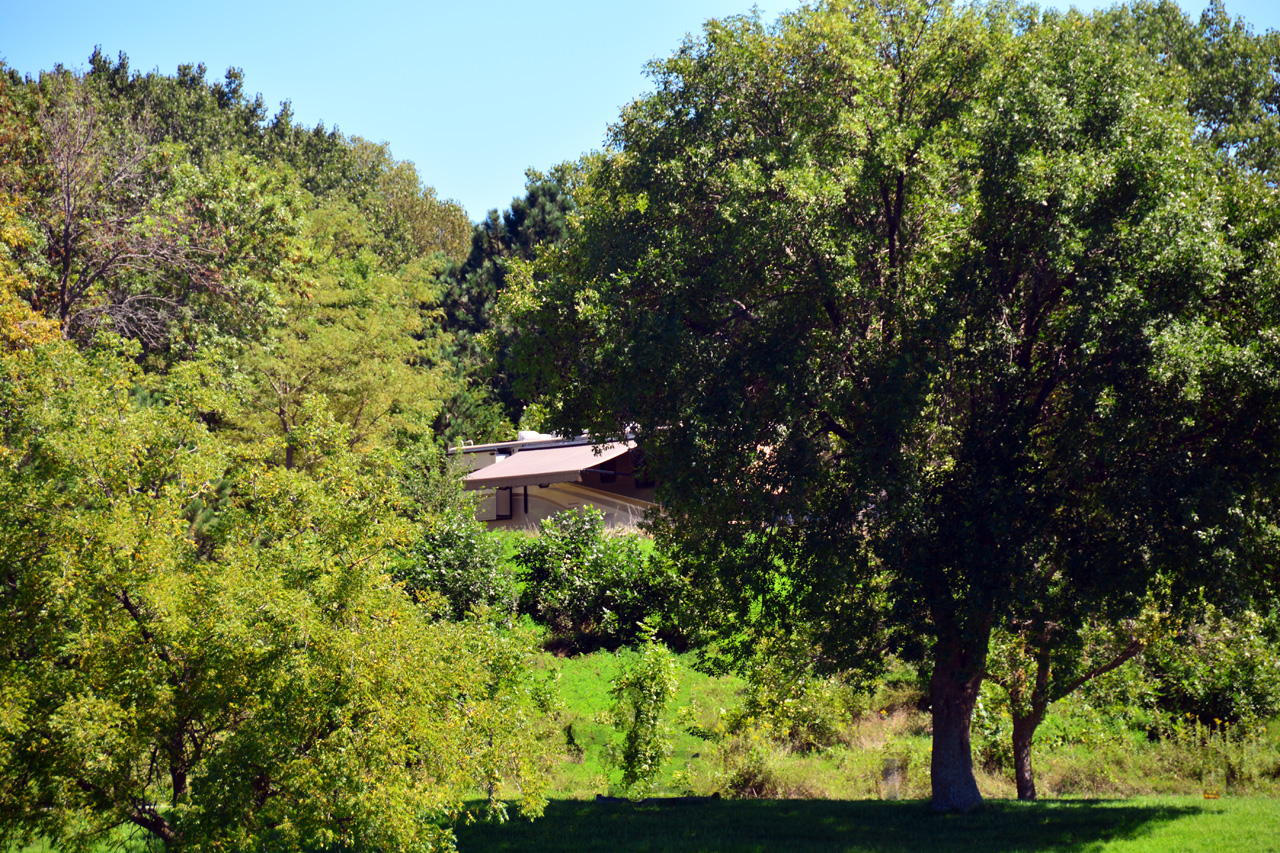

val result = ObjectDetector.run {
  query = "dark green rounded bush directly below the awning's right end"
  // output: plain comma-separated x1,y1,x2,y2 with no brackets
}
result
515,508,681,649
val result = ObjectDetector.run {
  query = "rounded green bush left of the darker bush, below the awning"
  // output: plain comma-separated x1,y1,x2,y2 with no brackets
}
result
396,504,518,620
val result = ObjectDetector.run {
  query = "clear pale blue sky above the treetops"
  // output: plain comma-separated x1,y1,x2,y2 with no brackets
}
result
0,0,1280,219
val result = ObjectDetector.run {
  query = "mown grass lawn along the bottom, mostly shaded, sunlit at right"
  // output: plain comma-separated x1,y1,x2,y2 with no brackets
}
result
13,797,1280,853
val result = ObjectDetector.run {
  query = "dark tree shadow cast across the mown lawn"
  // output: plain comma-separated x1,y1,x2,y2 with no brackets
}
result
457,800,1201,853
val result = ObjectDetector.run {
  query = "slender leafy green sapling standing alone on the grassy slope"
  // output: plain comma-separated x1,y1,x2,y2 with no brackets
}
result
608,626,677,795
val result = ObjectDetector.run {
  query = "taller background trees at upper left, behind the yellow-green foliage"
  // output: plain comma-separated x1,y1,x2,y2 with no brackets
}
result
3,51,471,399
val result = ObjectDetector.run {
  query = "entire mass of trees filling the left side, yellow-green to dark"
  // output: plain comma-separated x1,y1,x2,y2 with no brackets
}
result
0,53,545,849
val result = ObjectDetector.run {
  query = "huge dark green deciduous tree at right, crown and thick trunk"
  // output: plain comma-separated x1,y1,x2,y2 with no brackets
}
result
504,0,1280,809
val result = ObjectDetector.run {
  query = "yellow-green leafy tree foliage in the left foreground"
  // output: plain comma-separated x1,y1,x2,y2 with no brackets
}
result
0,343,547,850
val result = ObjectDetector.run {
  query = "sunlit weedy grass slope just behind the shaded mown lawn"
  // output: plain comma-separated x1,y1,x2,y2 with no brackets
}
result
541,652,1280,811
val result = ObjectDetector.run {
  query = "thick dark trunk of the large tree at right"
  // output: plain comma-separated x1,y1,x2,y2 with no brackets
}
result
929,639,986,812
